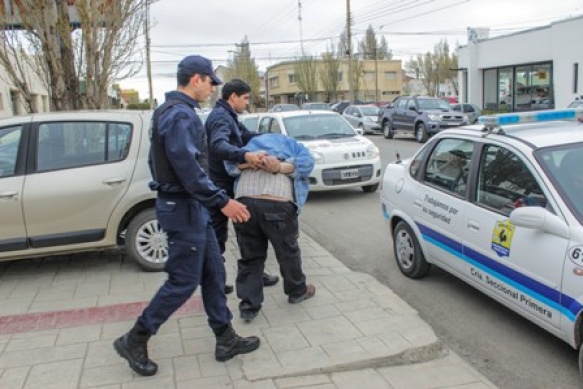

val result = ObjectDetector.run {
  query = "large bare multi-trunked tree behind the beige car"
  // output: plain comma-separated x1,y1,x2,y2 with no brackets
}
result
0,0,145,111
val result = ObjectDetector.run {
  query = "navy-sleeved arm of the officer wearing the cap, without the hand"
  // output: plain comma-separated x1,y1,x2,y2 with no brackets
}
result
164,113,229,208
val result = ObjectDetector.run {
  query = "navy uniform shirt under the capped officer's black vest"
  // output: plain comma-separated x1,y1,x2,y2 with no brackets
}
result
150,91,229,208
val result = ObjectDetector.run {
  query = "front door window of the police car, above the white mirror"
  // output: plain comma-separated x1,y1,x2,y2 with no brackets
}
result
476,145,547,215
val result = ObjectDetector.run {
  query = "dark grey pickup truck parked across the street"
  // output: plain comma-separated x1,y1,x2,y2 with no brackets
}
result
379,96,468,143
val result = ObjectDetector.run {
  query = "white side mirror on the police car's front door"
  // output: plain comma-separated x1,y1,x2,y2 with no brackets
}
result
510,206,569,239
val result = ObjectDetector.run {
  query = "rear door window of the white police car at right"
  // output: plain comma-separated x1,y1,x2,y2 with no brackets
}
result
423,139,474,196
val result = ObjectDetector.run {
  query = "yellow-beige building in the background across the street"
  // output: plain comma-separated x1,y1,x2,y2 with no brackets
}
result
265,60,403,107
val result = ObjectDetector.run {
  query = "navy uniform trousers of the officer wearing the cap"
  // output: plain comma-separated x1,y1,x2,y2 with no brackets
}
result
138,198,233,334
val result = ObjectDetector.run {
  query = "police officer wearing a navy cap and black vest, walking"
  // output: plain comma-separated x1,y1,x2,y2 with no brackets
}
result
114,55,259,376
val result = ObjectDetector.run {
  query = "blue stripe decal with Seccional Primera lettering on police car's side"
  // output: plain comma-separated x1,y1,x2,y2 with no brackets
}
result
417,223,583,321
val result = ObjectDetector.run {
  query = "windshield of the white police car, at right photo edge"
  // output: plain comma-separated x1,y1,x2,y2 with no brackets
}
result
536,143,583,224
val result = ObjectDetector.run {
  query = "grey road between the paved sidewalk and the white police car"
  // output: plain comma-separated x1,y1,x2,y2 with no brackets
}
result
301,136,579,389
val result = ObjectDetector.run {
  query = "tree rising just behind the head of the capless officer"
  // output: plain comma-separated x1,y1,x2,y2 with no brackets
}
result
226,36,264,107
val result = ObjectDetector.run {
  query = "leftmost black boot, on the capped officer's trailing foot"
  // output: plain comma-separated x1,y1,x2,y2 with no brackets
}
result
113,322,158,376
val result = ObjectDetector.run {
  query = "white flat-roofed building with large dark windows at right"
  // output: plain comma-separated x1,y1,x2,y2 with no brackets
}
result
458,15,583,111
